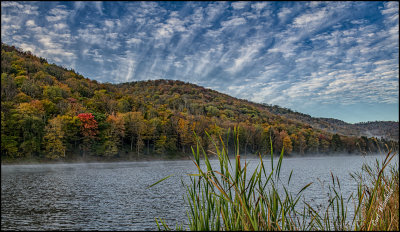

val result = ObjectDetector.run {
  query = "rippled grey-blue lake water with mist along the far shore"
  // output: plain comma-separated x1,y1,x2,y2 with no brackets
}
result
1,155,398,230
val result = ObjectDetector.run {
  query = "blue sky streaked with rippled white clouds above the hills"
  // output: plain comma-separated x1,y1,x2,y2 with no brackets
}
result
1,1,399,123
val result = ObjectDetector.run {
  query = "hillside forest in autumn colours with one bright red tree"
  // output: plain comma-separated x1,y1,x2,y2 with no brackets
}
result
1,43,398,161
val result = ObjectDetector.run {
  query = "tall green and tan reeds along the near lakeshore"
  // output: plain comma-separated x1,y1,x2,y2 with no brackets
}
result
152,128,399,231
